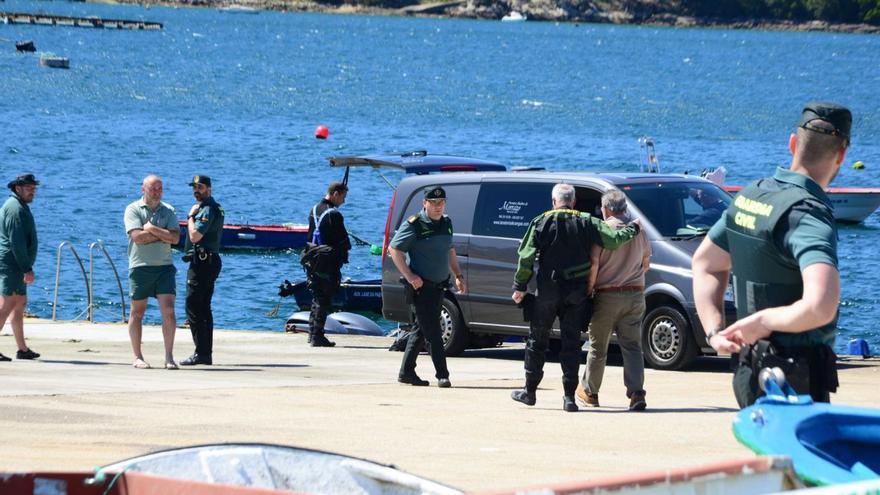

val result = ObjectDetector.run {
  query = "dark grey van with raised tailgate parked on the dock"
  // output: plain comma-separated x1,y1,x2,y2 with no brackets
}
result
330,152,736,369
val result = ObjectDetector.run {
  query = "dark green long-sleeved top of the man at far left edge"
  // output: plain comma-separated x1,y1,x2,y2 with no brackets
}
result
0,193,37,276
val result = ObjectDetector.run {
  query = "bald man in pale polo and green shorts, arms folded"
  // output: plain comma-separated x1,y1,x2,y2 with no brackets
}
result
125,175,180,370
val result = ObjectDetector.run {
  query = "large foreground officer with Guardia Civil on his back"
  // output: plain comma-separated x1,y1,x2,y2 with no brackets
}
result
693,102,852,407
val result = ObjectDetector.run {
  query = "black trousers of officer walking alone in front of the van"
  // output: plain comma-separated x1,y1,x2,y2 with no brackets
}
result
399,280,449,379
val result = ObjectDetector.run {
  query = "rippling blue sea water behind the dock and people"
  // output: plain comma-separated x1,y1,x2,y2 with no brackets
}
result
0,0,880,356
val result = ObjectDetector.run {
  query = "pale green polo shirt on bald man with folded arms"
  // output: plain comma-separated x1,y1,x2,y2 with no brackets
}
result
125,198,180,270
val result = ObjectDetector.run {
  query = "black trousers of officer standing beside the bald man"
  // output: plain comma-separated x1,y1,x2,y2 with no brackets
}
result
186,253,223,358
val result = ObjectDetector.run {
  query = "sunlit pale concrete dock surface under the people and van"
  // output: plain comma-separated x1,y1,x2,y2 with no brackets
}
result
0,322,880,490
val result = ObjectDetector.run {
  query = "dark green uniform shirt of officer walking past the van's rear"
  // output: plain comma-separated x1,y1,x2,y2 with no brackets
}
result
391,209,452,283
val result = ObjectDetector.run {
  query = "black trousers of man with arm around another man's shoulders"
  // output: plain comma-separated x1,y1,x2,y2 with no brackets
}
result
525,278,593,396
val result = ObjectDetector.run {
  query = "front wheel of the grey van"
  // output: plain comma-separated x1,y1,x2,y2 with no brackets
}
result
642,306,698,370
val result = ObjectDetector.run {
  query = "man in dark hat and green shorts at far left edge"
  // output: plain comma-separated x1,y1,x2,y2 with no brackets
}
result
0,174,40,361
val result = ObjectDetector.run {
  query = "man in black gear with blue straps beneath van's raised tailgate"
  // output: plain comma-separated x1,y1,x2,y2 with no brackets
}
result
308,182,351,347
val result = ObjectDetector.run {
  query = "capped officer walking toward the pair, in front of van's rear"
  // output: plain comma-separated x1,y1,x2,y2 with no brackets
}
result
389,186,467,388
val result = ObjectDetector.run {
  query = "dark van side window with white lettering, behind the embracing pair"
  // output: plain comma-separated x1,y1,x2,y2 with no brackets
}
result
473,182,553,239
